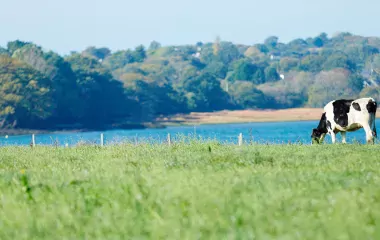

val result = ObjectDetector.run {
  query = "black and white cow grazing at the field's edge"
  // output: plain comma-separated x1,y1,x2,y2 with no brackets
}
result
311,98,377,143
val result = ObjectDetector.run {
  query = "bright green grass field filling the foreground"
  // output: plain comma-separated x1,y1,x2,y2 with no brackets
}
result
0,142,380,240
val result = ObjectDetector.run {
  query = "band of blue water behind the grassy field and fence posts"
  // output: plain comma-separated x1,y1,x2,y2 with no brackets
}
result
0,119,380,146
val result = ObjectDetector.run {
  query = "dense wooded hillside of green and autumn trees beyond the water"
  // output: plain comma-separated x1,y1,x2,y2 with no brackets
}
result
0,33,380,129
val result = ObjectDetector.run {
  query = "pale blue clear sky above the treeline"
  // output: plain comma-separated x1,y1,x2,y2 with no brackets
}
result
0,0,380,54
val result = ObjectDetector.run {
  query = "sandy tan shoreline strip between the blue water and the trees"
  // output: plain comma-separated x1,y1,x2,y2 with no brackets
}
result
0,108,380,136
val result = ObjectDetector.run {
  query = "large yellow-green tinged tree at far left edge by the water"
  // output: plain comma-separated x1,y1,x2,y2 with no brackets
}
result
0,55,55,128
